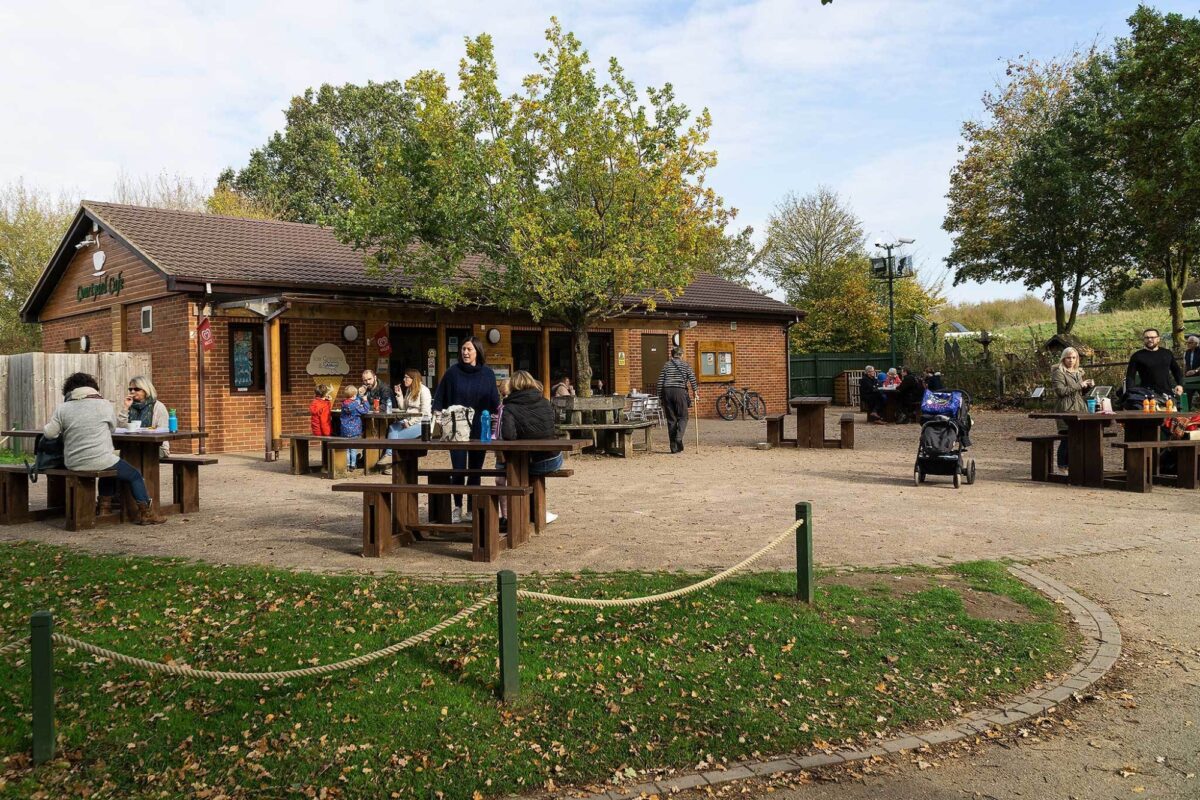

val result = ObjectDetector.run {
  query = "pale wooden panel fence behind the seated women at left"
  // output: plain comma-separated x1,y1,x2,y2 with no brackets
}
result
0,353,152,450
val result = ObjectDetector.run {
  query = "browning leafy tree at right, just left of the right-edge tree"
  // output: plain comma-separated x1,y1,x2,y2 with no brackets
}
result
942,53,1130,332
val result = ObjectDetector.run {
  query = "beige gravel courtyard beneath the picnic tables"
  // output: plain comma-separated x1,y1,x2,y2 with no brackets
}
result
0,411,1196,576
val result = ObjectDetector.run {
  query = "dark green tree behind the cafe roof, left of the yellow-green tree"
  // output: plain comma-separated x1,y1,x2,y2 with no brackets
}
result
217,80,414,223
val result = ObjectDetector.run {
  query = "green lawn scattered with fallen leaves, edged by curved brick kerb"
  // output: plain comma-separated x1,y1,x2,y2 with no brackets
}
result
0,545,1074,799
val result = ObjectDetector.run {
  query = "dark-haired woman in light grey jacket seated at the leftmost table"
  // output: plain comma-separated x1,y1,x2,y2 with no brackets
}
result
43,372,167,525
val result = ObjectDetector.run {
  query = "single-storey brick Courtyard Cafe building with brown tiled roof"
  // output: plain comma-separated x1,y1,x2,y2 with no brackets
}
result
22,201,800,457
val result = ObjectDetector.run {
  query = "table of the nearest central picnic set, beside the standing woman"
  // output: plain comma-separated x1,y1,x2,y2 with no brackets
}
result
340,439,586,546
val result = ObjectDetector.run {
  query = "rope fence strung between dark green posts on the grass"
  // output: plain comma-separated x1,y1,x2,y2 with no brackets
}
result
0,503,814,764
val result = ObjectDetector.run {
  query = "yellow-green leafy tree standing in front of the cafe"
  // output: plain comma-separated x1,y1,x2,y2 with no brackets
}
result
334,19,734,390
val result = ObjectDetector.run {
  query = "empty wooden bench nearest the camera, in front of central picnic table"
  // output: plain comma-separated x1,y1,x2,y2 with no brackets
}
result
334,483,532,561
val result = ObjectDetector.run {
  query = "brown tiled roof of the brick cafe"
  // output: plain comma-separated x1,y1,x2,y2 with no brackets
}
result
83,200,798,317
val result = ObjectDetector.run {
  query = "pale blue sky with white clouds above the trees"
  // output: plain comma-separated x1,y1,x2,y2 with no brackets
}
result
0,0,1200,300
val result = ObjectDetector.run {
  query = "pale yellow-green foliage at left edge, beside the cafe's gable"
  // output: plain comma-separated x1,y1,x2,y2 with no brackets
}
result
0,181,76,353
